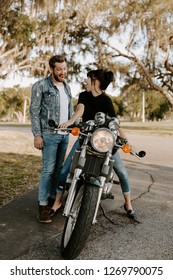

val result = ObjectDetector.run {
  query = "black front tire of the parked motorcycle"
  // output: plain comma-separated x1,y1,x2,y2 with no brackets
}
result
61,184,99,260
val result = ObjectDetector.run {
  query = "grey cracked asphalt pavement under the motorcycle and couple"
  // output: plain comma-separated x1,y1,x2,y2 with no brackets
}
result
0,159,173,260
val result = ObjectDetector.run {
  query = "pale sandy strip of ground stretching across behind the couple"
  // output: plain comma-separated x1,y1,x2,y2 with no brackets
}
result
0,121,173,167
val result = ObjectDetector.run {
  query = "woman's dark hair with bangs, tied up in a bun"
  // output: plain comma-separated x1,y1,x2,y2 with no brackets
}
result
87,69,114,90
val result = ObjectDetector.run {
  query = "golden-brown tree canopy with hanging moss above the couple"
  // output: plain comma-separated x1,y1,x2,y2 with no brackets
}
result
0,0,173,105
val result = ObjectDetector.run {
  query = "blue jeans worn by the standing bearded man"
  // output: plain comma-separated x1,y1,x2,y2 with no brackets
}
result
38,132,69,205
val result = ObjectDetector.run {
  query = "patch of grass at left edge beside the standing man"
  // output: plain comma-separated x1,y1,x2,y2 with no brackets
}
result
0,153,41,206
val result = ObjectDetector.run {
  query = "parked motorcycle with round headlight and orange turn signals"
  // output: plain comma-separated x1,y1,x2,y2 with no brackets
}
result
49,112,145,260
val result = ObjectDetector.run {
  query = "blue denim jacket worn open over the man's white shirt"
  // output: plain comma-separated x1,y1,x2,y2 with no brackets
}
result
30,75,73,136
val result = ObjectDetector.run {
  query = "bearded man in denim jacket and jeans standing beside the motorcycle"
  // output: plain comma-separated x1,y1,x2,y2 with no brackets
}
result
30,55,73,223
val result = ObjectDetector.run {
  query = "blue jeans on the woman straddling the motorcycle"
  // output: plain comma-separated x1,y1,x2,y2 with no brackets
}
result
60,140,130,194
